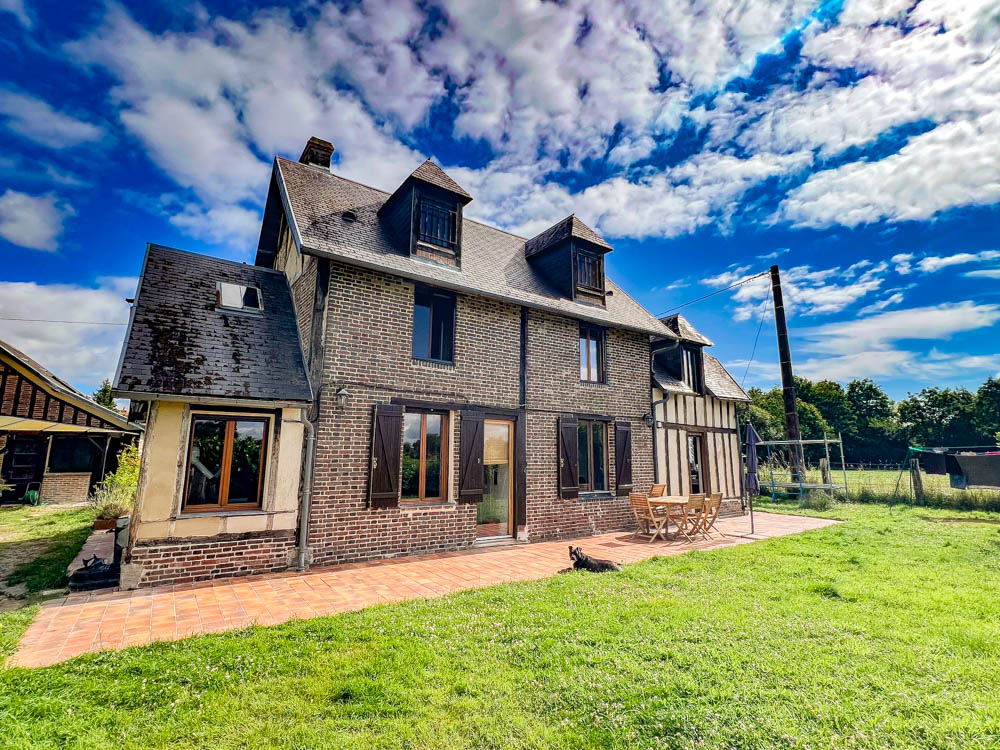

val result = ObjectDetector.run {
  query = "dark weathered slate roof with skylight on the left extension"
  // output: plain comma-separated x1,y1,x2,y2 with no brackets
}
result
114,244,312,402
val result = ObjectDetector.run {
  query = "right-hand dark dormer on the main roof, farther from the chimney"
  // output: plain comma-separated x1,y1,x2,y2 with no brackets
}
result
524,214,611,305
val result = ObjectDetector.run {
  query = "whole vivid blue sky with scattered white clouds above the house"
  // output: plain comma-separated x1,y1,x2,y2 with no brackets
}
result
0,0,1000,397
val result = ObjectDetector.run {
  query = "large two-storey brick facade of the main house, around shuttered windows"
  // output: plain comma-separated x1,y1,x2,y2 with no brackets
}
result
300,263,653,564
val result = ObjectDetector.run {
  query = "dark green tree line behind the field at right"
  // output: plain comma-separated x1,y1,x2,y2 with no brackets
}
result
742,377,1000,463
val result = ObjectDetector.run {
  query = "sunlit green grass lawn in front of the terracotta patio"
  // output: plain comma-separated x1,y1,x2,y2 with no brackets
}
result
0,505,1000,750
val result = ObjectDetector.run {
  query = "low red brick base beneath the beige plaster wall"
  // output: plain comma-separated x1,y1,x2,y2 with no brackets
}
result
123,531,295,587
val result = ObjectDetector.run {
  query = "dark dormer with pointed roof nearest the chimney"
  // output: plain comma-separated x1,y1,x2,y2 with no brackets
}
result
379,159,472,267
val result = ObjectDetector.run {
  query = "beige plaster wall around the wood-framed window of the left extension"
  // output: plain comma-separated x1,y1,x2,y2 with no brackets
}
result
131,401,303,543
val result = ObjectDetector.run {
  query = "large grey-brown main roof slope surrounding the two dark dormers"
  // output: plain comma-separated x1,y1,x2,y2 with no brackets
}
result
275,157,673,338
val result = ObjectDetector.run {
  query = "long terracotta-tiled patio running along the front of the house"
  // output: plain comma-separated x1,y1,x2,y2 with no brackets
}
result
7,513,836,667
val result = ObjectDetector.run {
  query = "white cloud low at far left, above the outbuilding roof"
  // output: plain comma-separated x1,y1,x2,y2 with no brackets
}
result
0,277,137,394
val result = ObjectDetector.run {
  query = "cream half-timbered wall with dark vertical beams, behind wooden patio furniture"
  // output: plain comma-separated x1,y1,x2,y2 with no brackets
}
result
653,388,743,510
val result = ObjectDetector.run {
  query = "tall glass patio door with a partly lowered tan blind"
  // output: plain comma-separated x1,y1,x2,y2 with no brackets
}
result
476,419,514,539
